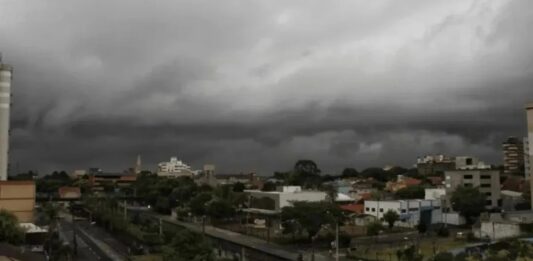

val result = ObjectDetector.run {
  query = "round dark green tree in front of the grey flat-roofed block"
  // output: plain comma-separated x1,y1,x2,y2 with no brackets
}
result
451,187,486,224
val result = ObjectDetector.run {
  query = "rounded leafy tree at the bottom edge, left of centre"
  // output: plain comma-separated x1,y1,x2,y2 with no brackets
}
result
162,229,214,261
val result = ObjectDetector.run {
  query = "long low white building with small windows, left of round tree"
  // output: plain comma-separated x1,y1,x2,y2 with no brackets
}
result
364,199,442,227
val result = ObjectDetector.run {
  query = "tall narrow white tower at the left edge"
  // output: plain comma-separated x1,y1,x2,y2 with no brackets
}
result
0,56,13,181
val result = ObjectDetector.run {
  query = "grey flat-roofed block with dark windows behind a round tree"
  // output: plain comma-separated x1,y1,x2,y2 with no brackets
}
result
445,169,501,208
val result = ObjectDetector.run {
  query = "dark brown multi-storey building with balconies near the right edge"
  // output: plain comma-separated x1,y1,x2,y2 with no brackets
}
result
502,137,524,175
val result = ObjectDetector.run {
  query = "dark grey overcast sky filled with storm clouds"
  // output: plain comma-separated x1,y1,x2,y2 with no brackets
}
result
0,0,533,175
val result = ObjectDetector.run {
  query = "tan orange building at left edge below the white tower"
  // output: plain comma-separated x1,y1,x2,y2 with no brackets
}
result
0,180,35,223
